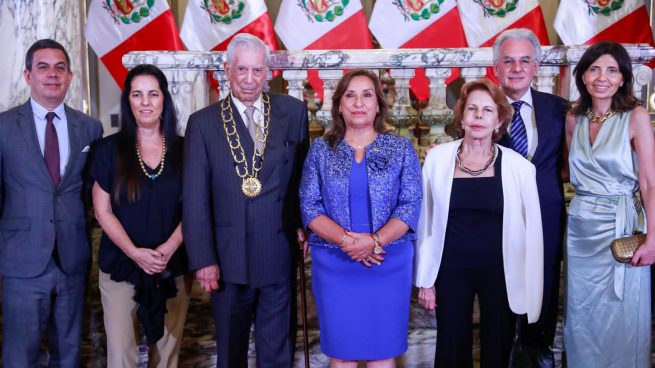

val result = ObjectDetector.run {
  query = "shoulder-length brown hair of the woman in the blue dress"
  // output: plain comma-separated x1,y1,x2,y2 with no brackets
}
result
324,69,389,148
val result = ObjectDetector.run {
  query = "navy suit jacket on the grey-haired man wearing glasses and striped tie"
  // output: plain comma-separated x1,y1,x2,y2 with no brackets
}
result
498,89,566,266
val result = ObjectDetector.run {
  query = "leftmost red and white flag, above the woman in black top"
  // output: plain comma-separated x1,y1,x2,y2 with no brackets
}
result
84,0,182,88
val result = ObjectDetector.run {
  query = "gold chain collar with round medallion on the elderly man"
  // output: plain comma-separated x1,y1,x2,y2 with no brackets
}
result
221,92,271,198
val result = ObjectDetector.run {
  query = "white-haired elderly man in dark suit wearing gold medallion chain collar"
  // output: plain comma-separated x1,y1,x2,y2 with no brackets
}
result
182,34,308,368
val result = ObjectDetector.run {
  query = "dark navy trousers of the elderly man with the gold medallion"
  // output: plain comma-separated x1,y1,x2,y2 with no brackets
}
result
211,281,295,368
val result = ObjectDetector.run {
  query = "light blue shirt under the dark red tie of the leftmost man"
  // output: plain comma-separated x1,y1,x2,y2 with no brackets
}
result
30,98,70,177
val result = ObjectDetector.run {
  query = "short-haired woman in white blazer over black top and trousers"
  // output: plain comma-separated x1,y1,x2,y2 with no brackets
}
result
414,80,543,368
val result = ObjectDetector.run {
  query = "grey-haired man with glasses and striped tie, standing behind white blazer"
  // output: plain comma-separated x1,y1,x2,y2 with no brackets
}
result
493,29,566,344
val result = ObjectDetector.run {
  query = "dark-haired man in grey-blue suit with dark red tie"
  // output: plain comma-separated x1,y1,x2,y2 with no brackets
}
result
0,39,102,367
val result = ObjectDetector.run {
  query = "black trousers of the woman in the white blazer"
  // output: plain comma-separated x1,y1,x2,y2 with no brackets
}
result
435,265,516,368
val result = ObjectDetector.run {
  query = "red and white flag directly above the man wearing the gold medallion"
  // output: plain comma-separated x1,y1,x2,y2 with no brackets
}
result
180,0,278,51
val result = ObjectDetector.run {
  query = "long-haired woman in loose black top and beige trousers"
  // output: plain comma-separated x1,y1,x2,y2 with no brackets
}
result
91,65,191,367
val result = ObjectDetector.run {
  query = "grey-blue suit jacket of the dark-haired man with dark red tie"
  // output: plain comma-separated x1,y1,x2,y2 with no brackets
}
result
0,101,102,277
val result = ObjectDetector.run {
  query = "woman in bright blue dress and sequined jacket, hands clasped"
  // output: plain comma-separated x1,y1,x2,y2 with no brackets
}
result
300,69,422,367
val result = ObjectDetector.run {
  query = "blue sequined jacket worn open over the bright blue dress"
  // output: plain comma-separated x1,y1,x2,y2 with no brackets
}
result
300,134,422,247
